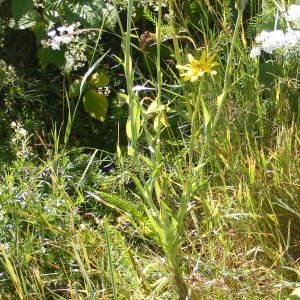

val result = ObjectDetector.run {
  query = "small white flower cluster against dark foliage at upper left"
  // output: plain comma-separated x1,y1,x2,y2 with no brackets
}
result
48,24,76,50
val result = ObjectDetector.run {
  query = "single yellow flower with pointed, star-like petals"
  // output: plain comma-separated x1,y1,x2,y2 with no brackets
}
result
176,50,218,82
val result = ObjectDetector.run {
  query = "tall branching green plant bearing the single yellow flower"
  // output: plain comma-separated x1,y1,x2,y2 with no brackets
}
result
98,1,248,299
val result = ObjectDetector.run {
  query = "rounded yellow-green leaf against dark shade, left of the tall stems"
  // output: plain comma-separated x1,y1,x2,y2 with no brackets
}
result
83,89,108,122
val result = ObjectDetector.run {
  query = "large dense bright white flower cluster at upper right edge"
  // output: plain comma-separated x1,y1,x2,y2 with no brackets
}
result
250,4,300,58
